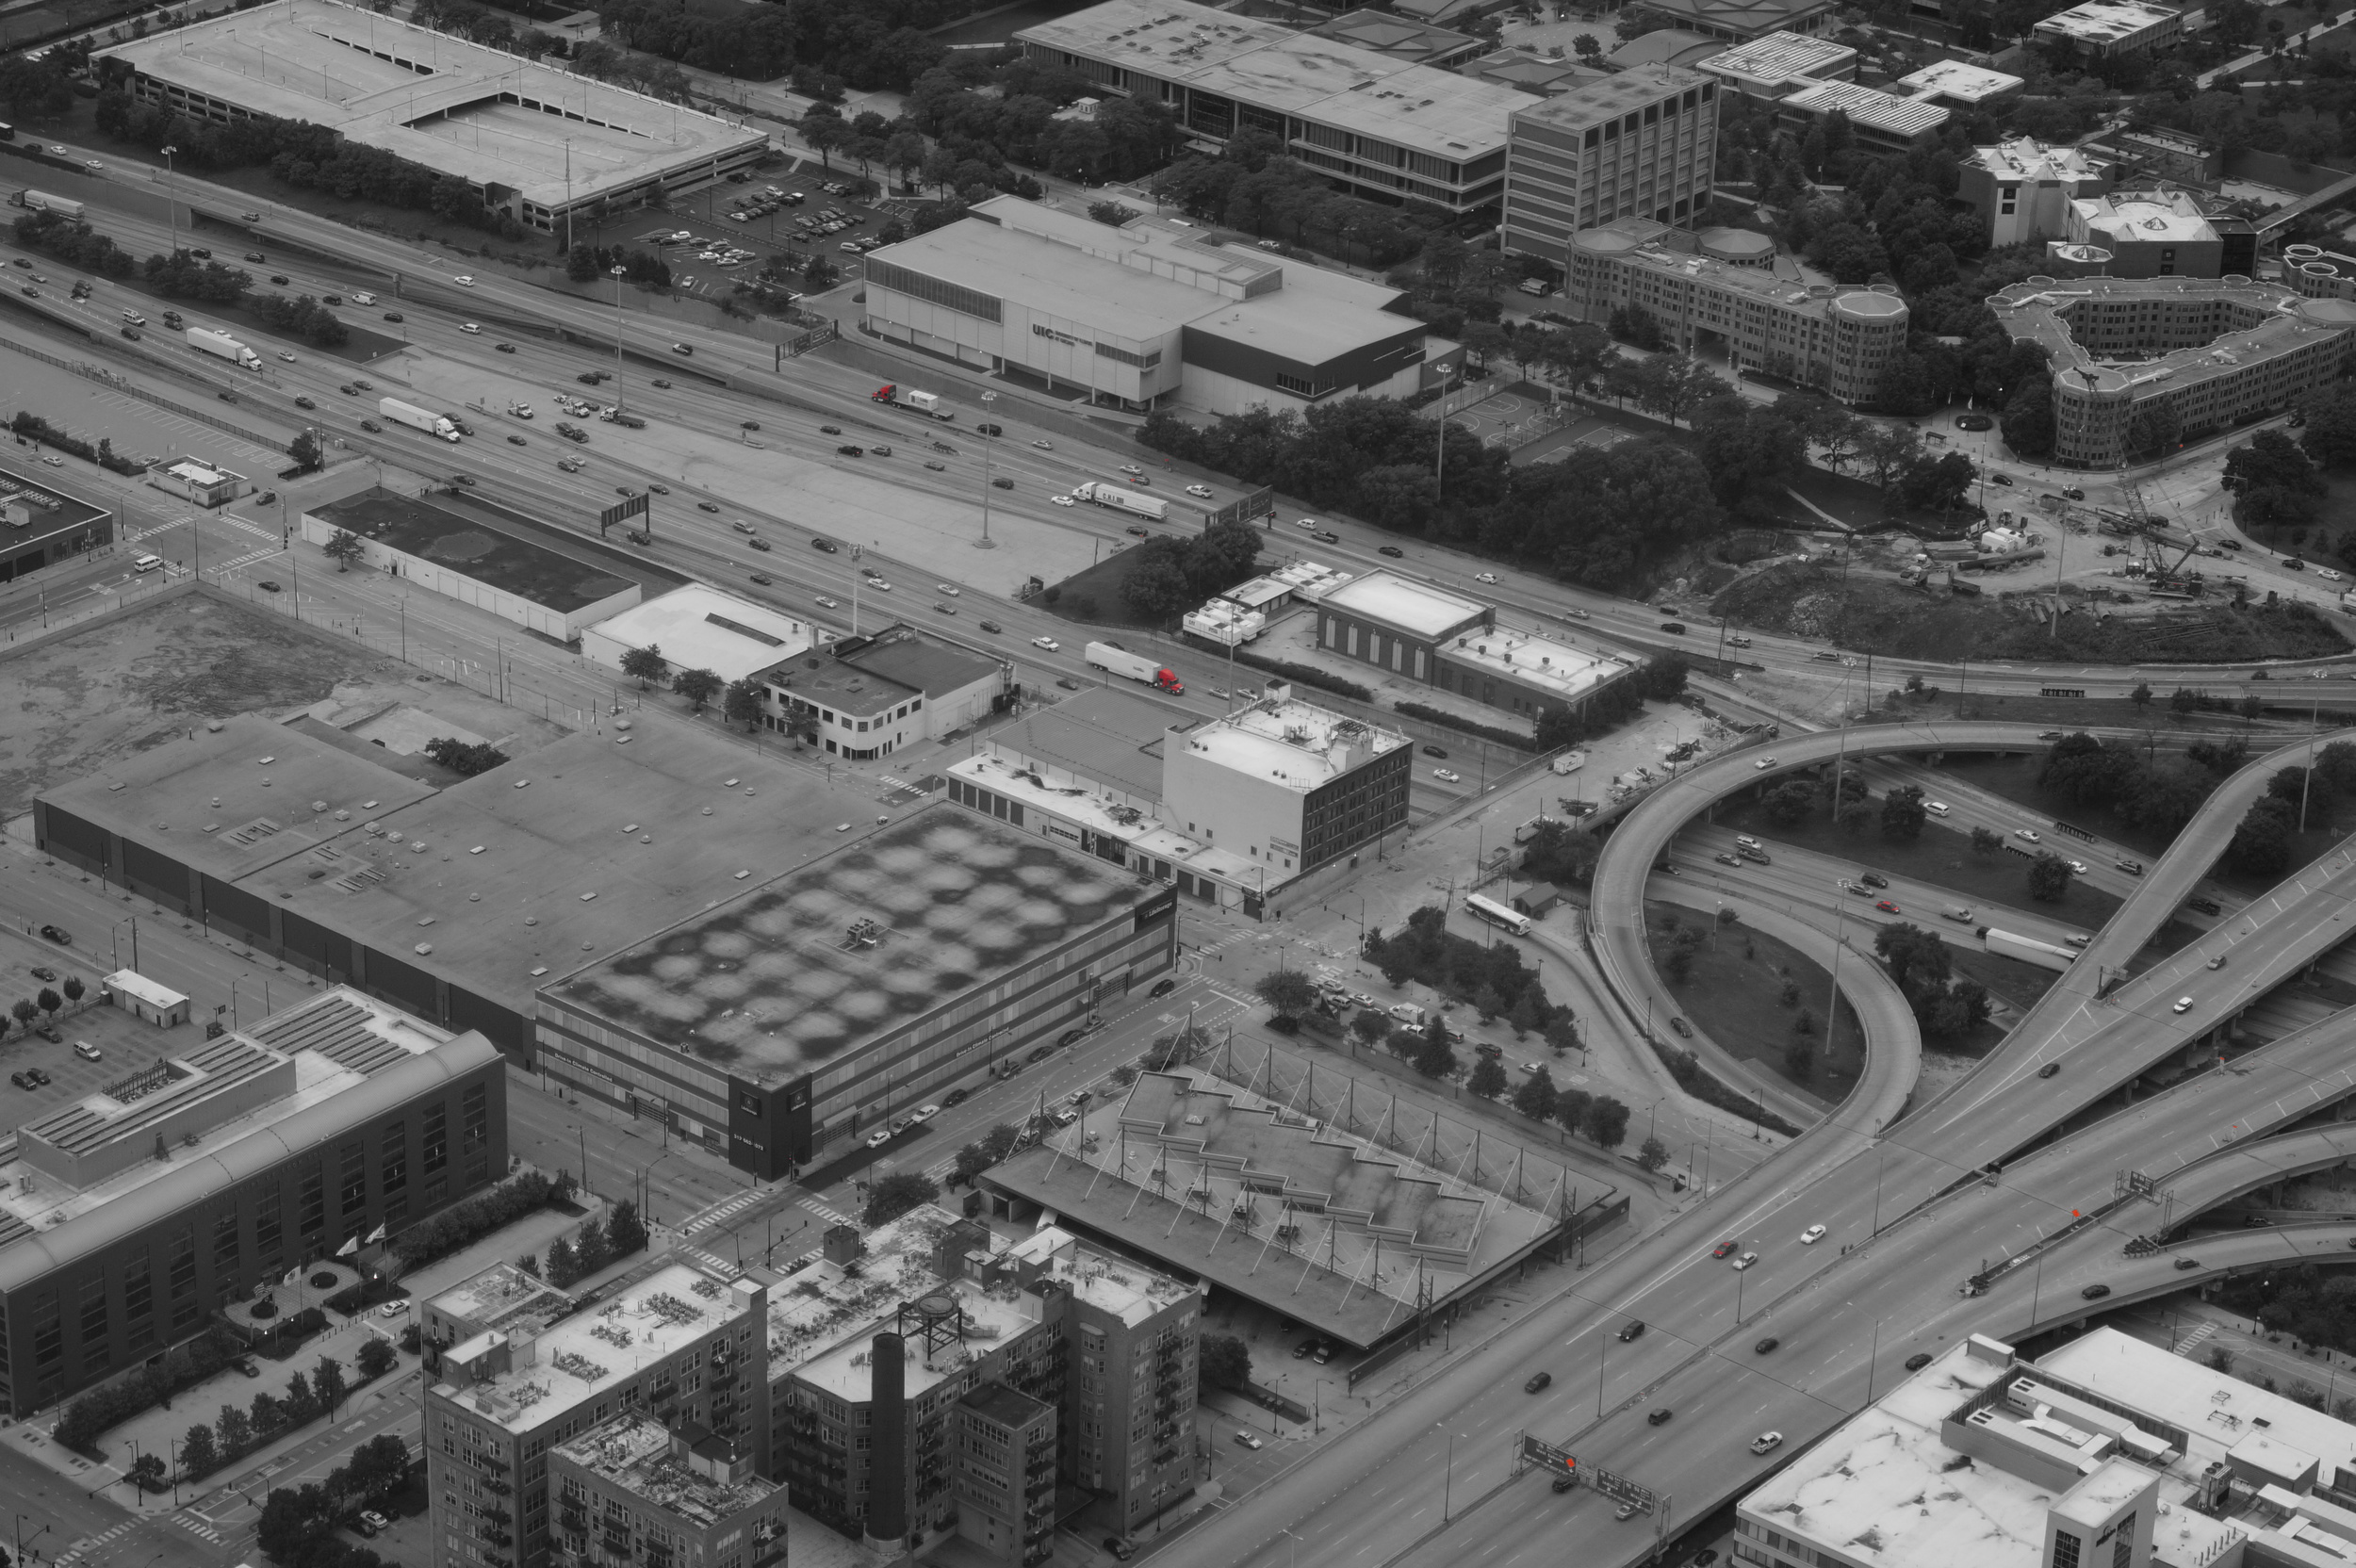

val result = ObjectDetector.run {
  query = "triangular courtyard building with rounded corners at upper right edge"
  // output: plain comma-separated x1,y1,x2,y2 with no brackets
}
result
1988,278,2356,468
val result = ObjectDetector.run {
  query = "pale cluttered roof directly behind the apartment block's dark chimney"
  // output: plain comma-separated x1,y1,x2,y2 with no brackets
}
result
768,1203,1044,1403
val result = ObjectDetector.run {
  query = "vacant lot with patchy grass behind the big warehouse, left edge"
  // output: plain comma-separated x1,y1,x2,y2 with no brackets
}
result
0,594,402,817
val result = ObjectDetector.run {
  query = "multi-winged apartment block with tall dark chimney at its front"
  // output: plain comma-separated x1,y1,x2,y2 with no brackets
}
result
768,1205,1202,1535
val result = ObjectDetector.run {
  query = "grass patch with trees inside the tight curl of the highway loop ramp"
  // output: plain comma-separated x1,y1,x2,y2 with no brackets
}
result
1644,904,1866,1109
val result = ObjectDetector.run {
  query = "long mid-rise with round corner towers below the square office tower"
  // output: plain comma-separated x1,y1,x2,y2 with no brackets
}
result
1560,219,1906,402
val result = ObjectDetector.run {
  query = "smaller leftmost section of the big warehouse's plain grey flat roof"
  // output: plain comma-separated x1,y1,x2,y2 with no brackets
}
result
41,713,434,883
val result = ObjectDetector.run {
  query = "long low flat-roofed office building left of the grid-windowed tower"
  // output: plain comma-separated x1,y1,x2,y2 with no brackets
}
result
1016,0,1527,212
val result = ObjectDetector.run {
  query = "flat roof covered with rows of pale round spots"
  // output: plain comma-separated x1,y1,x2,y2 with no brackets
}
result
547,800,1159,1087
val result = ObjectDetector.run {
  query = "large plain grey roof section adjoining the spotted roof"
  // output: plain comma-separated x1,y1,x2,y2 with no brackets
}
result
234,711,876,1017
